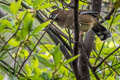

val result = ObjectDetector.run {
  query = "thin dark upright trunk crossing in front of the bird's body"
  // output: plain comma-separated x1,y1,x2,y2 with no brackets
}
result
72,0,81,80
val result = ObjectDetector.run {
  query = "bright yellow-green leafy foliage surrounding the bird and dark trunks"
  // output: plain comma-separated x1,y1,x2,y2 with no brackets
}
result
0,0,120,80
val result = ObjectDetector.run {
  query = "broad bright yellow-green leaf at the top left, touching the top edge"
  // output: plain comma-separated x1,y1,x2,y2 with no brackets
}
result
10,0,22,15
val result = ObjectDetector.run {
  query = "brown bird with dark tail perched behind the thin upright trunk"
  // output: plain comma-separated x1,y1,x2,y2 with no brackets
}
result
49,9,112,41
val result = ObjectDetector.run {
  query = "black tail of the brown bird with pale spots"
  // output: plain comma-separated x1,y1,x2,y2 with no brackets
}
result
92,23,112,41
